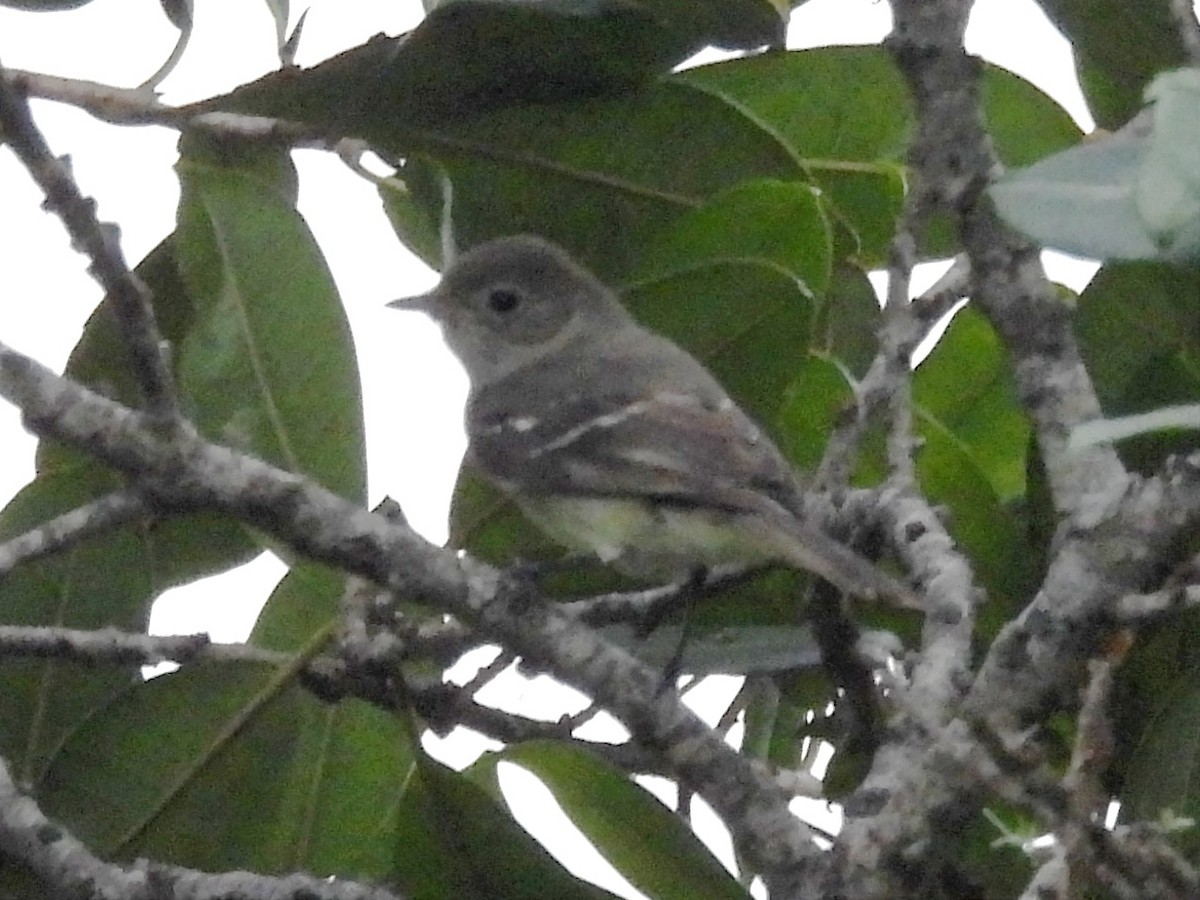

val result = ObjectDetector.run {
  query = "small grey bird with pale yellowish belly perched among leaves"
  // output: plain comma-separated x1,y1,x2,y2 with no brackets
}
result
389,235,918,606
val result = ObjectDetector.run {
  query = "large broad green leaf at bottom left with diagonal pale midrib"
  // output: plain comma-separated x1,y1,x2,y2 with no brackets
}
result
40,664,412,878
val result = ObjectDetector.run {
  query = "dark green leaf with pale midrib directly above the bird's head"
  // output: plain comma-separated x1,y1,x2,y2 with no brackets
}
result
379,83,802,281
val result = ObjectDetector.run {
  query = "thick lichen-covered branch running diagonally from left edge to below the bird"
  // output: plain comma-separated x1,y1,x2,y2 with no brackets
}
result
0,344,820,888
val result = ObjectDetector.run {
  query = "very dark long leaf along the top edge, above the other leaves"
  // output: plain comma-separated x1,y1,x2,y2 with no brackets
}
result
205,0,785,134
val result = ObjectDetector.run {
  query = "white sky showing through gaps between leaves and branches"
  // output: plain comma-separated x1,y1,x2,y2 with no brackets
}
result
0,0,1108,898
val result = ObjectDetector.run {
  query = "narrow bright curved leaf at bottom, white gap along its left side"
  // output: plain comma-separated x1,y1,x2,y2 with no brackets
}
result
476,740,746,900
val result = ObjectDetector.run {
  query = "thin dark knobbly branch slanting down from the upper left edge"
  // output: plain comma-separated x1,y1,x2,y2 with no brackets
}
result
0,68,179,425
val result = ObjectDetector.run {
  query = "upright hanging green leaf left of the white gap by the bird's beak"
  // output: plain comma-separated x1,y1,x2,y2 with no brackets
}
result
176,156,366,502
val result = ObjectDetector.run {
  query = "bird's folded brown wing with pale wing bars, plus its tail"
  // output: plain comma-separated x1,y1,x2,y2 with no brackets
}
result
469,384,919,608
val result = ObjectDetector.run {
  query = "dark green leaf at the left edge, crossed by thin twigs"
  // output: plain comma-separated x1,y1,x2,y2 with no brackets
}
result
0,468,154,782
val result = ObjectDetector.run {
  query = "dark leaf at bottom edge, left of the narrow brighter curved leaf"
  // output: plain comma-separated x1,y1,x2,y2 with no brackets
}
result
394,755,612,900
